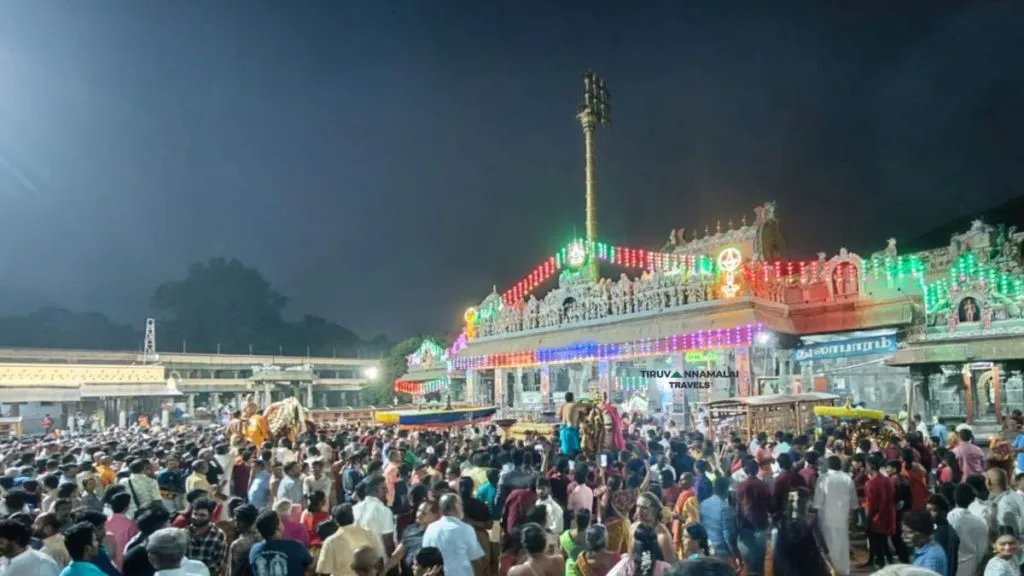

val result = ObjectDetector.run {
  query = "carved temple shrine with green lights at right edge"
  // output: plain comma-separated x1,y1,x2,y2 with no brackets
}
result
888,220,1024,424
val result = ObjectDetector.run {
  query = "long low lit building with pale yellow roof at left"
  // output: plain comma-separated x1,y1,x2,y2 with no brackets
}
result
0,348,380,434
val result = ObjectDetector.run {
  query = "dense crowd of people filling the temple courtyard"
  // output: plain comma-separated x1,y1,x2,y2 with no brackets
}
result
0,399,1024,576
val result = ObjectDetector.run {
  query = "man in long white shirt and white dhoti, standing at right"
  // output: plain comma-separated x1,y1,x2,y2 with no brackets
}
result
814,456,860,576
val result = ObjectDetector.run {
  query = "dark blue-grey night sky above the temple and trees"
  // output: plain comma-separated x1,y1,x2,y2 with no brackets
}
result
0,0,1024,338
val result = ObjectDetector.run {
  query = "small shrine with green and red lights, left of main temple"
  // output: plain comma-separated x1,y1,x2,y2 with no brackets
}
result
394,338,466,402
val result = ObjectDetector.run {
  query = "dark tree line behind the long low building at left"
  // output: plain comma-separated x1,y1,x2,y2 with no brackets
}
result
0,258,391,356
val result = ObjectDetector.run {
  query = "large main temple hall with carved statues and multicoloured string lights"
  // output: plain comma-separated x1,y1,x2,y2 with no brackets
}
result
449,203,924,412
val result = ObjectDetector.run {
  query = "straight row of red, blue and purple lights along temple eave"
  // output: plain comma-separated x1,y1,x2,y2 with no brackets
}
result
451,324,762,370
